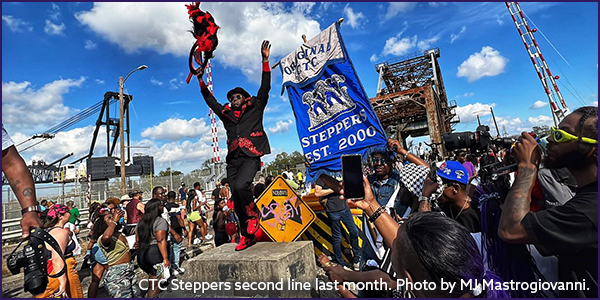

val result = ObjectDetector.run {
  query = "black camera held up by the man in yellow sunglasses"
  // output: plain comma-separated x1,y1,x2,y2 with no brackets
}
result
442,125,514,153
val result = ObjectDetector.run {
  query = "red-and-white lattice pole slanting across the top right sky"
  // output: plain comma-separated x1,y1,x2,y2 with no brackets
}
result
505,2,569,127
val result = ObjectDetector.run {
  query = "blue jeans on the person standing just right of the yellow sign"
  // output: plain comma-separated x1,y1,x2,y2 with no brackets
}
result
327,206,360,265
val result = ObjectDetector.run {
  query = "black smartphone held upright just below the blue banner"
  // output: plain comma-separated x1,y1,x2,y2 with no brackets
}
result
342,154,365,200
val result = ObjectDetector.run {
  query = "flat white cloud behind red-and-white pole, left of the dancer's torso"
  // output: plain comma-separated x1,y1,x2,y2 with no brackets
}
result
141,118,225,143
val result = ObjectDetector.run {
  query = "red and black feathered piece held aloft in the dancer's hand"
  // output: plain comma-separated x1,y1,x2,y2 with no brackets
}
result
186,2,219,83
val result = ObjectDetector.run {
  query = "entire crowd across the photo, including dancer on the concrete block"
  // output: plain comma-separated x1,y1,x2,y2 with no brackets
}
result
2,32,598,298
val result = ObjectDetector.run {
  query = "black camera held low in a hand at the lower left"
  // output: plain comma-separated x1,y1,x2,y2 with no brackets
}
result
6,233,48,295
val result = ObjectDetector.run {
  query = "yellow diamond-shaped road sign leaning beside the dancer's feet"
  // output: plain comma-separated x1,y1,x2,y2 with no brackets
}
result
256,175,316,242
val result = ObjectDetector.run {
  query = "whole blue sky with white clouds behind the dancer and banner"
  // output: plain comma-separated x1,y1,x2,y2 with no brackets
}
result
2,2,598,172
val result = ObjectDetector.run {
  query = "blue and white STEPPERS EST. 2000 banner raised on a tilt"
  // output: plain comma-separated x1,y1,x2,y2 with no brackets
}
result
280,24,386,181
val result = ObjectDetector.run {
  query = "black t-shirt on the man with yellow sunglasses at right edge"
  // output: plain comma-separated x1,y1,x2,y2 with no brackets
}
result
521,181,598,298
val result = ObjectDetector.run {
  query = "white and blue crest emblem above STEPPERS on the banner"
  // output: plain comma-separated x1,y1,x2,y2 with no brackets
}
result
302,74,356,131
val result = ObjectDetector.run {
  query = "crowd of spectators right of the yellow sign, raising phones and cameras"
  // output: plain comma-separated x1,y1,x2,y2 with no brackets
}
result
316,107,598,298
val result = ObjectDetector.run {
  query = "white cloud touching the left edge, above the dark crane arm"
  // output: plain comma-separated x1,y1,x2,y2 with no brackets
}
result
2,77,85,133
